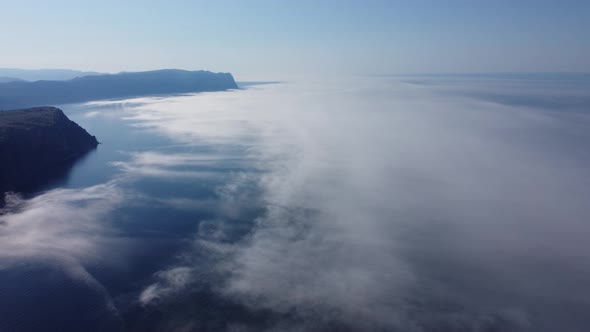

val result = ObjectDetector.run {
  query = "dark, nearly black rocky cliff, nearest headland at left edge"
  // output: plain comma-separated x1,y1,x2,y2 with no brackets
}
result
0,107,98,195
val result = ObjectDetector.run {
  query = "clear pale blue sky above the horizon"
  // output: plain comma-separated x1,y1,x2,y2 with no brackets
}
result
0,0,590,78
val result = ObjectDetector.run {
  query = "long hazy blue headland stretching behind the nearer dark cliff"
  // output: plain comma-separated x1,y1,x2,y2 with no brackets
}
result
0,69,238,110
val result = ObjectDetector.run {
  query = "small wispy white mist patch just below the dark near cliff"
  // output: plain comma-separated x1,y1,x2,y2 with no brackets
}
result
0,182,125,259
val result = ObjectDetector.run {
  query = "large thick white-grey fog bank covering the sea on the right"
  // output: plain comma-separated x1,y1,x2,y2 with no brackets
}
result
123,78,590,331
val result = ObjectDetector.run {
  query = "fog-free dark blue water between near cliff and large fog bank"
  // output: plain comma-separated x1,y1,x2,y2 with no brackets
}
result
0,92,268,331
